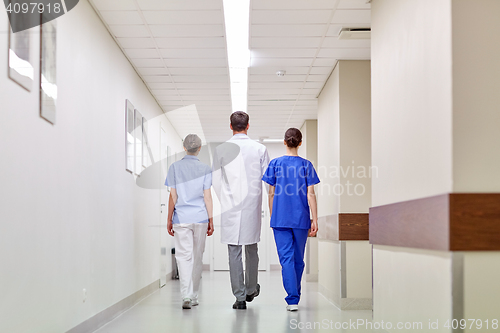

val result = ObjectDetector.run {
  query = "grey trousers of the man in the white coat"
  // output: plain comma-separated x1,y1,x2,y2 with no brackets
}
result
227,243,259,301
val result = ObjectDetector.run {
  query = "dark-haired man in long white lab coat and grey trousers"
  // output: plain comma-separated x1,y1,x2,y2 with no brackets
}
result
213,111,269,309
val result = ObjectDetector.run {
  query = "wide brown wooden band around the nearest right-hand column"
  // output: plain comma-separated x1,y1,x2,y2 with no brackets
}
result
369,193,500,251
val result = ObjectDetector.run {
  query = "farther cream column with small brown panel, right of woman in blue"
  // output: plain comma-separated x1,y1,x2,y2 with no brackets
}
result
318,60,372,310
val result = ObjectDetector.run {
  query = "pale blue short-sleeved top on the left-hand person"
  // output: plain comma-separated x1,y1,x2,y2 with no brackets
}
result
165,155,212,224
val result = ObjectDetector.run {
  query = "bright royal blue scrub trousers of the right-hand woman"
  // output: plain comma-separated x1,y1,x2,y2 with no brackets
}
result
273,228,309,304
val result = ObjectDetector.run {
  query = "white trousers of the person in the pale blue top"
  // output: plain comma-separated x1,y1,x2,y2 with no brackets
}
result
173,223,208,300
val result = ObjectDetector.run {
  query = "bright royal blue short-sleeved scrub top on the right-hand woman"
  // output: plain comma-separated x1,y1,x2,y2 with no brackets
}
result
262,156,319,229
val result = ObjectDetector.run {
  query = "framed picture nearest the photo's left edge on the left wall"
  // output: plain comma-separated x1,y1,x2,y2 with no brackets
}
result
8,14,35,91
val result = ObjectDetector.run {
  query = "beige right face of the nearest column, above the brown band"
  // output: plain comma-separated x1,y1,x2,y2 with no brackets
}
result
451,0,500,192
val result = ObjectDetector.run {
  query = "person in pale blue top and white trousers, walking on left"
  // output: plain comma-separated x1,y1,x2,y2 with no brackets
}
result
165,134,214,309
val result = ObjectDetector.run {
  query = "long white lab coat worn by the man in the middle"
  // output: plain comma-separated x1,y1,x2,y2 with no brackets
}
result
212,134,269,245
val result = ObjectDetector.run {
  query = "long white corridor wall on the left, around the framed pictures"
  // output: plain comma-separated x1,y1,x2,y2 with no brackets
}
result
0,1,181,333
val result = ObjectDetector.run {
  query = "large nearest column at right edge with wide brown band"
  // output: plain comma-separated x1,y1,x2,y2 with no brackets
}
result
370,0,500,332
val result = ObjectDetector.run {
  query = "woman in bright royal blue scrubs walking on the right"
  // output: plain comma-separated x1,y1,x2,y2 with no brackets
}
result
262,128,319,311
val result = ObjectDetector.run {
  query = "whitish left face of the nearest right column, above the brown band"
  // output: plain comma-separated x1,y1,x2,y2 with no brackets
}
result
371,0,454,206
